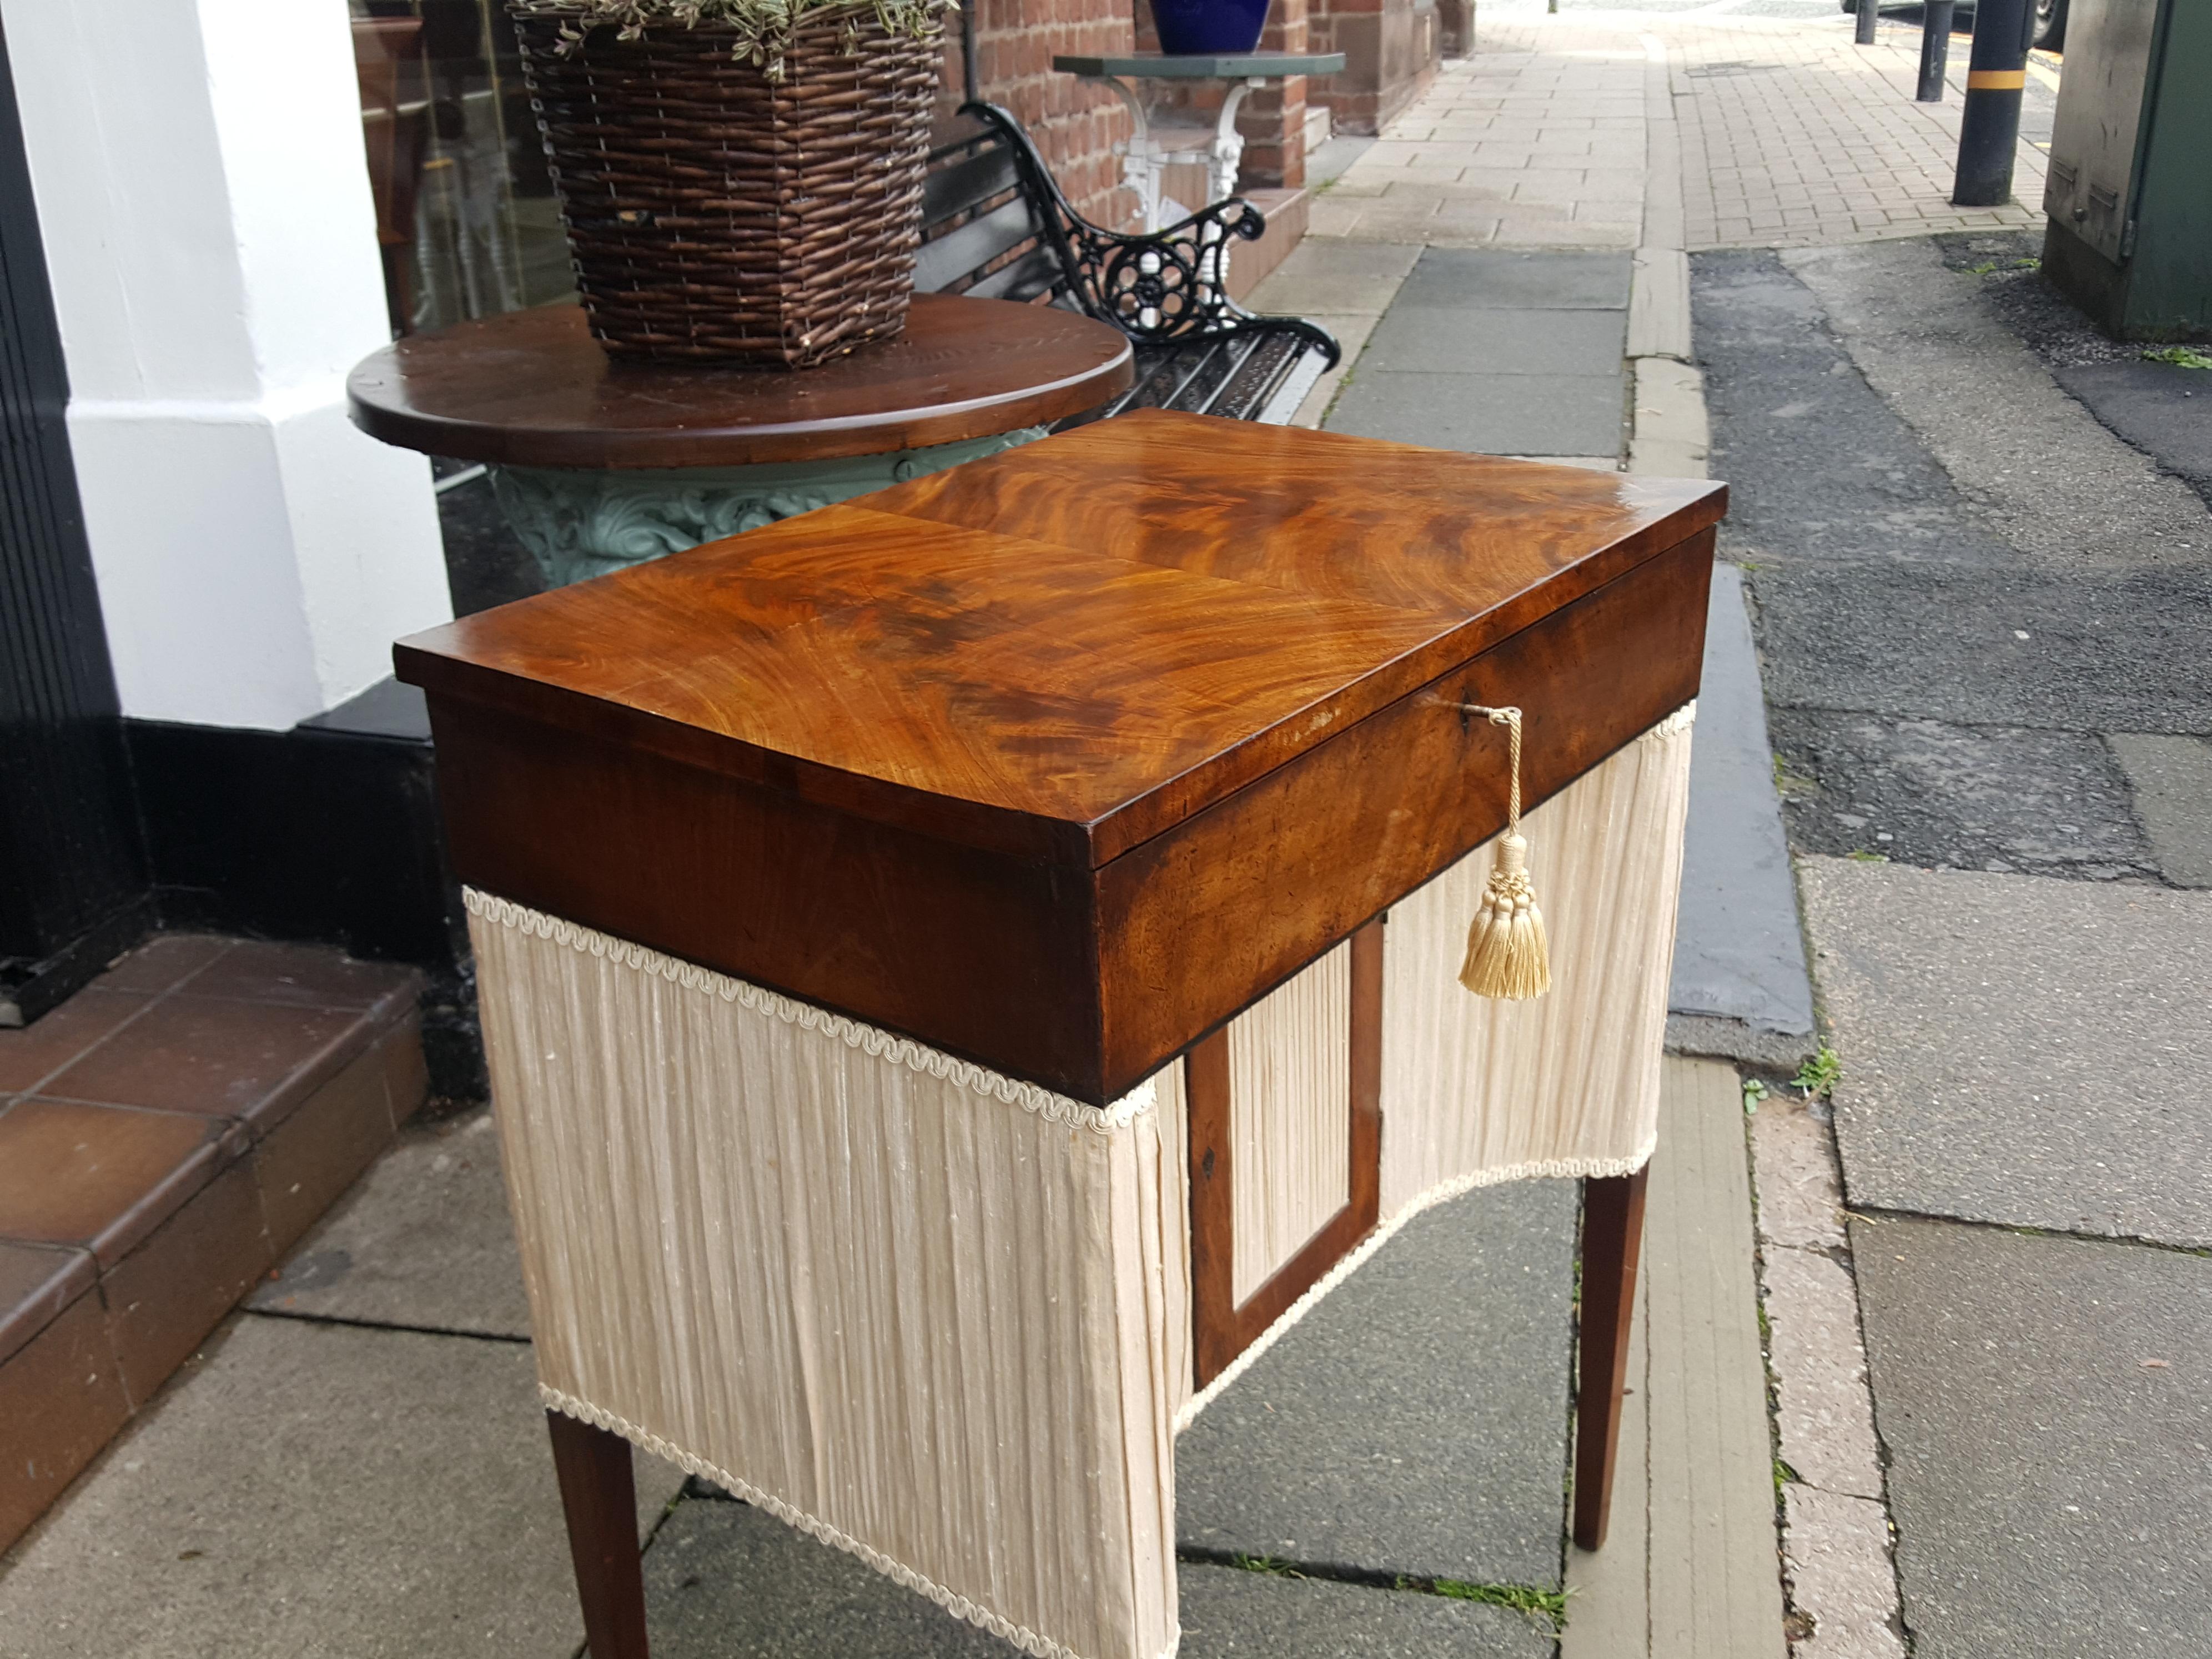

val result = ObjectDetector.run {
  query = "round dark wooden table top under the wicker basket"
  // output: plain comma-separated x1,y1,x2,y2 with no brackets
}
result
345,294,1133,469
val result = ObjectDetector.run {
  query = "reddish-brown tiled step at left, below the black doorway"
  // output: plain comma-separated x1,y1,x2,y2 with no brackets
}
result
0,933,427,1549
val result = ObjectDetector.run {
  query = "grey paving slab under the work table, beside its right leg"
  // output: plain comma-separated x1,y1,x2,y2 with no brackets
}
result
1175,1181,1580,1588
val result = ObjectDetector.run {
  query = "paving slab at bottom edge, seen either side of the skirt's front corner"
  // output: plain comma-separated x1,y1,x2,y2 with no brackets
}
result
646,1500,1551,1659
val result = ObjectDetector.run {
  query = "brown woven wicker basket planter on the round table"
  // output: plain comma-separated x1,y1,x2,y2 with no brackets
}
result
515,4,942,369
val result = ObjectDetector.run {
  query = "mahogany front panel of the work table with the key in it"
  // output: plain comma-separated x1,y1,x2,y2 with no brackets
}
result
1099,531,1712,1097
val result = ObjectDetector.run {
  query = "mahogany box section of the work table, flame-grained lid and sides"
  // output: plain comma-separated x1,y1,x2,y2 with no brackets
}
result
398,411,1726,1102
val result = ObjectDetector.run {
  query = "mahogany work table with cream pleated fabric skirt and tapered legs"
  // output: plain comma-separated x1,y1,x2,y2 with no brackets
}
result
398,411,1726,1659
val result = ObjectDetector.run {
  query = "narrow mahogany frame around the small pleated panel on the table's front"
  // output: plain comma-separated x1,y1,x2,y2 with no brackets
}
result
1183,922,1382,1389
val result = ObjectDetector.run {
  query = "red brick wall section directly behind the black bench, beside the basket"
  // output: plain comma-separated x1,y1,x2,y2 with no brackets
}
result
940,0,1142,228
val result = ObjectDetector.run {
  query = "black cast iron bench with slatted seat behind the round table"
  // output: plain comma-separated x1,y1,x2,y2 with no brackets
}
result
913,104,1343,425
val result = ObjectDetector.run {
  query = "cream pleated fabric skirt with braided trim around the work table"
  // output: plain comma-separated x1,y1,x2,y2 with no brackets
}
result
467,708,1692,1659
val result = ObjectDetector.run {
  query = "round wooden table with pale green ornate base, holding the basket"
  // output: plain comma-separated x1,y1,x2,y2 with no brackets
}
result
345,294,1130,586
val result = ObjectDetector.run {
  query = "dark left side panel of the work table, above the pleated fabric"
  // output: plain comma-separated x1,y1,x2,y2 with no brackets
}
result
431,699,1102,1102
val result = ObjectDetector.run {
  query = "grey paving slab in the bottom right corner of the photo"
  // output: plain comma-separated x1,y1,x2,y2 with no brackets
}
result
1852,1212,2212,1659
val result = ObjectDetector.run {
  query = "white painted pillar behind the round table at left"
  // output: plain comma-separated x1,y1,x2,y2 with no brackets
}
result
0,0,451,730
